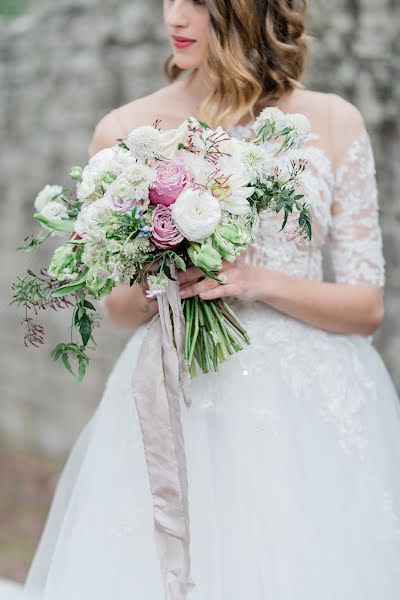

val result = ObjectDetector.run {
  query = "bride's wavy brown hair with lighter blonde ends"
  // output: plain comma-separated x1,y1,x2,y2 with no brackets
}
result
164,0,308,127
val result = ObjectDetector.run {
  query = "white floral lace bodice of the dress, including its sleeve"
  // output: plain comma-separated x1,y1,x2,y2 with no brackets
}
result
229,122,385,287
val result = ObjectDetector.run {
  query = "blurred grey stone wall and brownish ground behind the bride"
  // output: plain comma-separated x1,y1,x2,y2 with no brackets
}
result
0,0,400,581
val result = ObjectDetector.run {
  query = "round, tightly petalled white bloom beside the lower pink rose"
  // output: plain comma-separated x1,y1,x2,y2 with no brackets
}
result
172,188,221,242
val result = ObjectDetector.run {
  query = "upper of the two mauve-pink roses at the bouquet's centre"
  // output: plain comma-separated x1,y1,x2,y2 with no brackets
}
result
149,162,189,206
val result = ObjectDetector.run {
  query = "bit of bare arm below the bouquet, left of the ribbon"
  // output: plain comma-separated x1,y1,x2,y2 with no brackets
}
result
104,284,157,329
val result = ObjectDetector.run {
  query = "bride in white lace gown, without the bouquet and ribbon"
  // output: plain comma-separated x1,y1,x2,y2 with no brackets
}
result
1,0,400,600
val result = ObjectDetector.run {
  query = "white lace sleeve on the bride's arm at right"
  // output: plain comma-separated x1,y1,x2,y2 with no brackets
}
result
328,128,385,287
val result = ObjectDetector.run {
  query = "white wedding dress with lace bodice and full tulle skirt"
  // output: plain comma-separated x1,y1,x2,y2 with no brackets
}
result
0,115,400,600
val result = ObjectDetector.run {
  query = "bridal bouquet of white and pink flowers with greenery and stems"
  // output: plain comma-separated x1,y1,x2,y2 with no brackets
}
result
13,108,311,381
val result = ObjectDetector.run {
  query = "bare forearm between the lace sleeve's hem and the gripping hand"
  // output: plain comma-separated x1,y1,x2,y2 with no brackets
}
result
256,269,384,335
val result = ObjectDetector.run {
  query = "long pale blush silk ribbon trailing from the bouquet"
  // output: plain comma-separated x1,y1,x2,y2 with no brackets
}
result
133,264,195,600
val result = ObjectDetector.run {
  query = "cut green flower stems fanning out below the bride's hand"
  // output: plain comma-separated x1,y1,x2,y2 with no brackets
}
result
182,296,250,376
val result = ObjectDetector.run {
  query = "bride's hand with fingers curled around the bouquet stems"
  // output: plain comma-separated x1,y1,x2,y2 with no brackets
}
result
178,260,265,300
